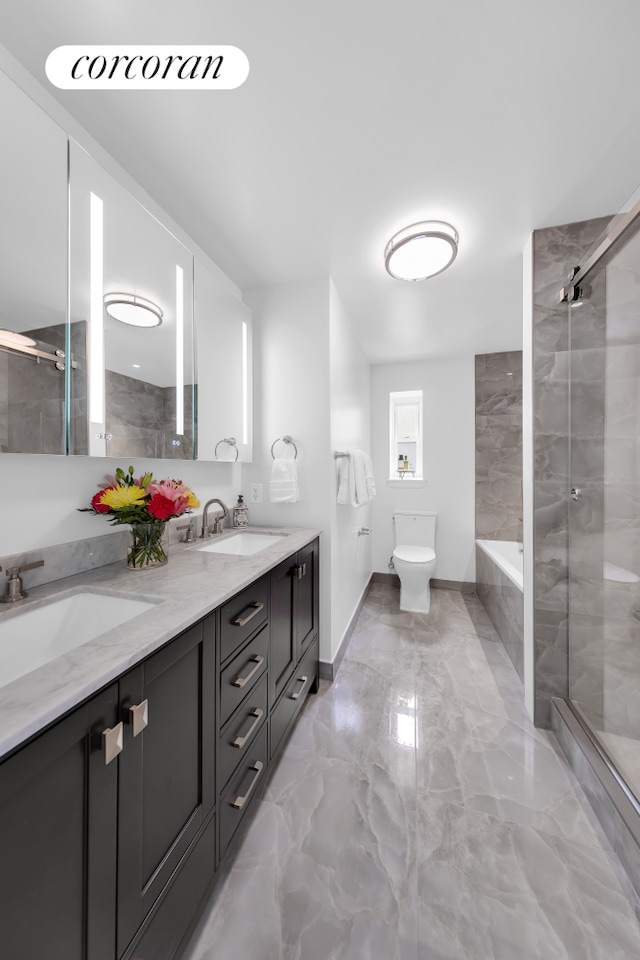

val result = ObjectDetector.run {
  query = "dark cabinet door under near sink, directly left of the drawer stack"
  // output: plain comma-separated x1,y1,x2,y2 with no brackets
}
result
118,617,215,956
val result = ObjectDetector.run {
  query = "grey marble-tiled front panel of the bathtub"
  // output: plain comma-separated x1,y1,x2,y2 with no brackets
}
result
476,547,524,681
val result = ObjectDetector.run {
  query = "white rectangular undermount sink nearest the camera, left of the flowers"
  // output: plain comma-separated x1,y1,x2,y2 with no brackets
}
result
0,590,155,687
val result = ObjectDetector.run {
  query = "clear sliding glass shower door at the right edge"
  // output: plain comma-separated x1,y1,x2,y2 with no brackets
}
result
568,204,640,798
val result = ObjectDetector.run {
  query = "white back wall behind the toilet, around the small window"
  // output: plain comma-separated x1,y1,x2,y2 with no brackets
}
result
371,354,475,581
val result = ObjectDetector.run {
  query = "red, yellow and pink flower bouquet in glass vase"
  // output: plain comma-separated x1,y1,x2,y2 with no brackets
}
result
82,467,200,570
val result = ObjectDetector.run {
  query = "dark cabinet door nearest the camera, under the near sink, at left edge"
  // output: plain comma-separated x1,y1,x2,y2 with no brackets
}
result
0,684,118,960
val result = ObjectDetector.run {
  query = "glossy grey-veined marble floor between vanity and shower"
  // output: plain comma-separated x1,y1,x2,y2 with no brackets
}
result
185,583,640,960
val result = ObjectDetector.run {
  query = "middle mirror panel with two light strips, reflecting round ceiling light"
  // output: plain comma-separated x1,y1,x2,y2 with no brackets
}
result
69,141,195,460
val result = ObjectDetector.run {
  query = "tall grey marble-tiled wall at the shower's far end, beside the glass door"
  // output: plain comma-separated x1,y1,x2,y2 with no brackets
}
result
533,217,609,727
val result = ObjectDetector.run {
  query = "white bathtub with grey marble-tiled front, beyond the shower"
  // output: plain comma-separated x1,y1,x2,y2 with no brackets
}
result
476,540,524,680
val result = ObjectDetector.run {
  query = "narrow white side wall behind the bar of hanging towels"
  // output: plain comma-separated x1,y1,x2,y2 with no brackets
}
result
329,282,372,660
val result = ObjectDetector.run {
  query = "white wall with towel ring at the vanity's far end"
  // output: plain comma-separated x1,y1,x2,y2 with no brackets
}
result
242,278,334,661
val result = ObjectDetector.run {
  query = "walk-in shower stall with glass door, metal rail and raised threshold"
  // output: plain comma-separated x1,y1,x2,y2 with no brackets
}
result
553,186,640,892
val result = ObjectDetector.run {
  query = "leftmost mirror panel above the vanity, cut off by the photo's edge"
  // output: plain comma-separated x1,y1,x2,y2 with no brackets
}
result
0,72,67,453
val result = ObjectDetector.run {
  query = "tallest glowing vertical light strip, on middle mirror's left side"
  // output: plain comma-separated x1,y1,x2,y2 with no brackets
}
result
89,193,104,423
